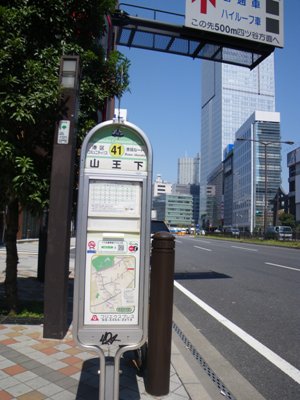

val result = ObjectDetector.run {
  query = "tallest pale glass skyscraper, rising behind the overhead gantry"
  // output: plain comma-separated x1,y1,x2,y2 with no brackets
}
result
200,54,275,216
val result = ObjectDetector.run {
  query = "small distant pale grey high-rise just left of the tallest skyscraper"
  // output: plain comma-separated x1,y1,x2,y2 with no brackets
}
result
177,153,200,185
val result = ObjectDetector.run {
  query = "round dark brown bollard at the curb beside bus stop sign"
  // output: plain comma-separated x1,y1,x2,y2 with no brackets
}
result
145,232,175,396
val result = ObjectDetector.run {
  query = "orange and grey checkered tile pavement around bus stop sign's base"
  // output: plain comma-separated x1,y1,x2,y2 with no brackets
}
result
0,325,189,400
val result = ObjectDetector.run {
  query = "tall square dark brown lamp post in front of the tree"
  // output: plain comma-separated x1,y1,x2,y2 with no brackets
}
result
43,56,79,339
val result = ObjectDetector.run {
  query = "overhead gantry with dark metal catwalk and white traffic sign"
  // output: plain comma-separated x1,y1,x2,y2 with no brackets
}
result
112,0,283,69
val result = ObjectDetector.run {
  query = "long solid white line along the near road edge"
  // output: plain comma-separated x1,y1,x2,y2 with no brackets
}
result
174,281,300,384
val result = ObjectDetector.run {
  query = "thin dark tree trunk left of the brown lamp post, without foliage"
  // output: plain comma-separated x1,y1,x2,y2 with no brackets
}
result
4,199,19,314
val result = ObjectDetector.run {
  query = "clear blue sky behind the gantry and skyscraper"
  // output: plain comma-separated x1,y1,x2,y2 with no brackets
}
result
119,0,300,190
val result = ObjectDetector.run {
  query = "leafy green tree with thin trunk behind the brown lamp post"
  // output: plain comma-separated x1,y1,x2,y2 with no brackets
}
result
0,0,129,312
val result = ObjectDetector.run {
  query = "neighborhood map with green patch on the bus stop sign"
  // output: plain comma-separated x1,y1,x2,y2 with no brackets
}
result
90,255,136,314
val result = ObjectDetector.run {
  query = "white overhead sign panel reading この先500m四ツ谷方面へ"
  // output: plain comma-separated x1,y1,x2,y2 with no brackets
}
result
185,0,283,49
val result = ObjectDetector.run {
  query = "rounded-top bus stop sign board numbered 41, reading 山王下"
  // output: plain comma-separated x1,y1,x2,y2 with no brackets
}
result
73,121,152,350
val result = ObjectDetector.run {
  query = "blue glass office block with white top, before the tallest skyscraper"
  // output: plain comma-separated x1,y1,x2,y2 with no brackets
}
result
232,111,281,233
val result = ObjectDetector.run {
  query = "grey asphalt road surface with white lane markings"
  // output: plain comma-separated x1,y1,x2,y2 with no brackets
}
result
174,236,300,400
